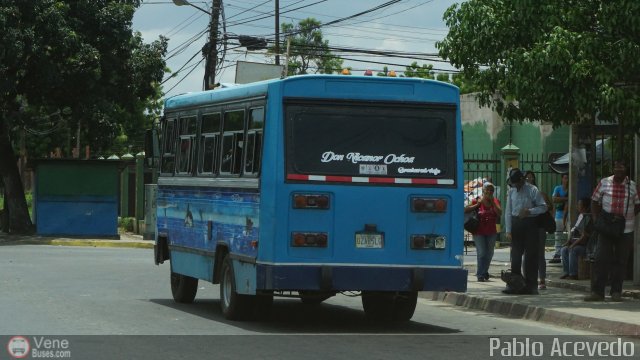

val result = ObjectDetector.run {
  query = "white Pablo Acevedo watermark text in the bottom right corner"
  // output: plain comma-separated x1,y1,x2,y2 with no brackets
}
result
489,337,635,358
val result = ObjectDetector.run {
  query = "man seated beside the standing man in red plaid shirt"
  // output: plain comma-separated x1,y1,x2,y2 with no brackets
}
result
560,198,591,280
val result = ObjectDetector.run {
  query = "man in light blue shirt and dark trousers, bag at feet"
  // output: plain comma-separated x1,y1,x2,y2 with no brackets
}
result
502,168,547,295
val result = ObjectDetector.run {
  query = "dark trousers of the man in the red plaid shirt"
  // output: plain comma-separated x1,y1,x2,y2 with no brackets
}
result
591,232,633,296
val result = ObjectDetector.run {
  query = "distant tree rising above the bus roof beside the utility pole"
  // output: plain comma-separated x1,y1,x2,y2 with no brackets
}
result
270,18,342,75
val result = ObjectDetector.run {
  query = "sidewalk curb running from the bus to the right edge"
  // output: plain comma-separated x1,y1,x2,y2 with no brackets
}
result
421,292,640,337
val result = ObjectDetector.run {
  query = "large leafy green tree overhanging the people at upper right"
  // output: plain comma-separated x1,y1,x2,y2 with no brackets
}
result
436,0,640,131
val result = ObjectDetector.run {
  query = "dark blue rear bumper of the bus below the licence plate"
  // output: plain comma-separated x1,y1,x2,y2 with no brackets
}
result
256,264,468,292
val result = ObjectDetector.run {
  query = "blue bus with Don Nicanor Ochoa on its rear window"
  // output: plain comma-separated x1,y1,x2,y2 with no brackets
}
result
154,75,467,321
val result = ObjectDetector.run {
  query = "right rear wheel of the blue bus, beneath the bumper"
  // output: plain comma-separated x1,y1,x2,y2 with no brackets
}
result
362,291,418,322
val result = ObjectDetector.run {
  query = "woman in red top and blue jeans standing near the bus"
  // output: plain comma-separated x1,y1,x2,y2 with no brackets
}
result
464,182,502,282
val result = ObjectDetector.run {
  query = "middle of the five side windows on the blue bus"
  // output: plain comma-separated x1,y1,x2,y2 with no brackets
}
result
198,113,220,174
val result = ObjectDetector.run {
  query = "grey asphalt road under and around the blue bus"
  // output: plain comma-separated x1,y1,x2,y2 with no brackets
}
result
0,245,624,359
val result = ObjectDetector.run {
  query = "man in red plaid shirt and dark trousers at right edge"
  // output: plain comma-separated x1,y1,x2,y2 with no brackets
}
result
584,160,640,301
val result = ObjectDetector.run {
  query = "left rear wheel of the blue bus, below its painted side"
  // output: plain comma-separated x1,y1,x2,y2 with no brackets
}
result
220,255,251,320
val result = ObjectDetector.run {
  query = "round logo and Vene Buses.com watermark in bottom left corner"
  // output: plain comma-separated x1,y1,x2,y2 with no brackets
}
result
7,336,71,359
